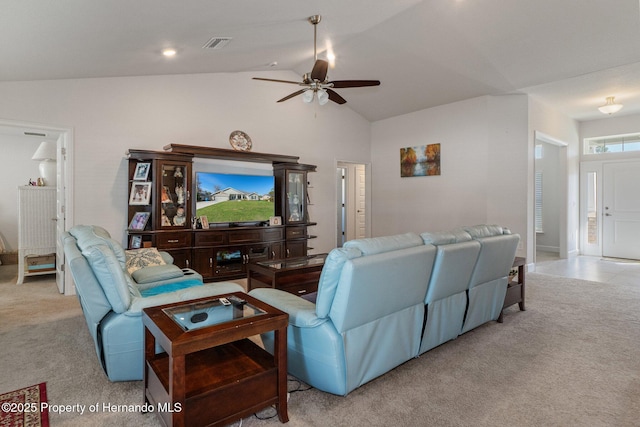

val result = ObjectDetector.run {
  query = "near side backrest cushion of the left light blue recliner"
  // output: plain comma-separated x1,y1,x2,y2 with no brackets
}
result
82,245,131,313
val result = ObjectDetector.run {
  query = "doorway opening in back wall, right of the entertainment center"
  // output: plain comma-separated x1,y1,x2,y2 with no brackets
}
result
336,161,370,248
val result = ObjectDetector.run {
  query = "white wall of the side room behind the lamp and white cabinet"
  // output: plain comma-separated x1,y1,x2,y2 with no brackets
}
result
0,134,42,252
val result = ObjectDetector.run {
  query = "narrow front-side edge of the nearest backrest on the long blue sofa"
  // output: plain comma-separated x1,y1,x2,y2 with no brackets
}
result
316,248,362,318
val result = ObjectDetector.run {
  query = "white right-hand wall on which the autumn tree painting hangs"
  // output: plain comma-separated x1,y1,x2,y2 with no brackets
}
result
371,95,528,252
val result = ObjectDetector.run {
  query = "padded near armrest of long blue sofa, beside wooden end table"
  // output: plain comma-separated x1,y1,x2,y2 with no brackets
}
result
249,288,327,328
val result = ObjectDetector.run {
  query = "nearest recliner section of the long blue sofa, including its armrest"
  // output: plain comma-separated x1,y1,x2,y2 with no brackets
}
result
250,233,436,395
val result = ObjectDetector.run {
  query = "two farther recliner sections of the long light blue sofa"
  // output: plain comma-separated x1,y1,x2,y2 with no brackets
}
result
420,225,520,354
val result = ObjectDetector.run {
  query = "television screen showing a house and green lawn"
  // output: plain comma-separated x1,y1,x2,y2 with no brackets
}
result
196,172,275,224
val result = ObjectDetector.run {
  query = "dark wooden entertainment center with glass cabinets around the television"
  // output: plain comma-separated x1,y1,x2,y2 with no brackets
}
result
127,144,316,281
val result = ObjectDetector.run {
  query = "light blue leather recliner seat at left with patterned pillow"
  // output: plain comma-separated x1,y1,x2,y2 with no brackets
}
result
61,225,244,381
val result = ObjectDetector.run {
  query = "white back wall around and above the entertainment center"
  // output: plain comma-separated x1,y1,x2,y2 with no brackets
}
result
0,72,370,252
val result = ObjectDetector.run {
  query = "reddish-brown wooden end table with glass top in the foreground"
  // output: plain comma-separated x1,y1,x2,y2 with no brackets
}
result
142,292,289,427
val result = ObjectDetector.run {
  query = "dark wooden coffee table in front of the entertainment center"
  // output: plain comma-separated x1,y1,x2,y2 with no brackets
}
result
247,254,327,296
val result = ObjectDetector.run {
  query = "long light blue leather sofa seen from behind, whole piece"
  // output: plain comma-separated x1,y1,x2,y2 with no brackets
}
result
250,225,519,395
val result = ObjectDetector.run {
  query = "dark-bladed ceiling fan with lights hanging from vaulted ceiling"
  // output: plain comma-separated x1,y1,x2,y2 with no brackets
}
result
253,15,380,105
